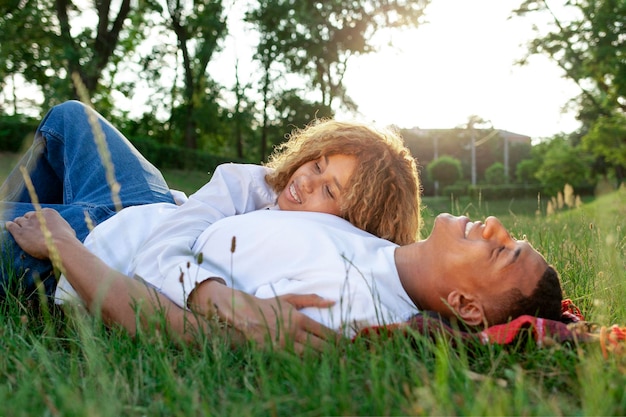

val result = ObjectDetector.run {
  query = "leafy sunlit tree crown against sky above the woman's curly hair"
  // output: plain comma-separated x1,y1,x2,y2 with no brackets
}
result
247,0,428,115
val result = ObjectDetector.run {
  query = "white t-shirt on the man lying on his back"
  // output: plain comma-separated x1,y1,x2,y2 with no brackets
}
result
149,210,417,335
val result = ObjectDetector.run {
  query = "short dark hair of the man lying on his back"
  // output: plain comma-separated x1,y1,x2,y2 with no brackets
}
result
486,266,563,326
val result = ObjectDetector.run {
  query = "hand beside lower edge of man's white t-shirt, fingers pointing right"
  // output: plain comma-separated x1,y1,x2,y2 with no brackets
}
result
189,280,339,353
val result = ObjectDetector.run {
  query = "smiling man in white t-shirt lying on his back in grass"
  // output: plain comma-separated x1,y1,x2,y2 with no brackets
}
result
6,209,561,350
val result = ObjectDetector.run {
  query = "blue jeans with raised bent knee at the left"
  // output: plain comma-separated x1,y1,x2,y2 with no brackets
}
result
0,101,174,299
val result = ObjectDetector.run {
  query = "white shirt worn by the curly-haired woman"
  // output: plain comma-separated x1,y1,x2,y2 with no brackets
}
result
55,164,277,303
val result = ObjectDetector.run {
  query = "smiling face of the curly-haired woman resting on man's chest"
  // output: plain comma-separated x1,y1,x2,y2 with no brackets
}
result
278,154,357,216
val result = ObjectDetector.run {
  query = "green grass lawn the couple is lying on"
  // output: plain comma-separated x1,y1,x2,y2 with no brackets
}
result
0,154,626,416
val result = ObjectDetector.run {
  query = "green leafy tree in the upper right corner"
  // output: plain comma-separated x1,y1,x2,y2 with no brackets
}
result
515,0,626,182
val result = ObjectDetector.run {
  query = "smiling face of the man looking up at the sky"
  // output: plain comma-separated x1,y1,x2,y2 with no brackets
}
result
425,214,548,303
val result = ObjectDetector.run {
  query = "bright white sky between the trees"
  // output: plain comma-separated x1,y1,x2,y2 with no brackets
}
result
211,0,579,138
